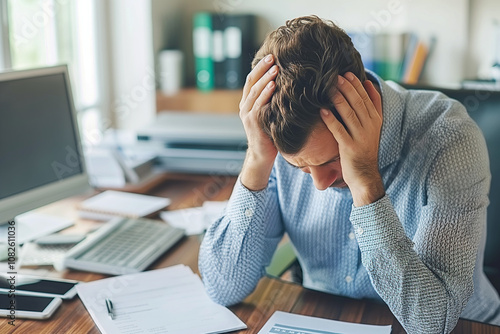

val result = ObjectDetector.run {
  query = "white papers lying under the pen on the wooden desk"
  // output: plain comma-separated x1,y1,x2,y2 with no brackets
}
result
77,265,246,334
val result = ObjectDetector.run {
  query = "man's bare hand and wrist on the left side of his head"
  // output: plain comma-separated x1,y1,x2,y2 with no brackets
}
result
240,55,278,190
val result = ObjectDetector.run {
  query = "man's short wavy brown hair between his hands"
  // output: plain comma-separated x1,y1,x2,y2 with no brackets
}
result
252,16,366,154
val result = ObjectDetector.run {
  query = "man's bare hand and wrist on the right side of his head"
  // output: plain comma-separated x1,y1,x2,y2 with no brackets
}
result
321,72,385,207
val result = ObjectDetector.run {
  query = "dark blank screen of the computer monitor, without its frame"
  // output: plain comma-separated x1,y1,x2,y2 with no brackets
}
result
0,74,82,199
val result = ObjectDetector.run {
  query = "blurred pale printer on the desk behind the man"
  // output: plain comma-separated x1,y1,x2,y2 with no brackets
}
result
137,111,247,175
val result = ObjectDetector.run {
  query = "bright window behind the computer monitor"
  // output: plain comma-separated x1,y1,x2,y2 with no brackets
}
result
0,0,104,142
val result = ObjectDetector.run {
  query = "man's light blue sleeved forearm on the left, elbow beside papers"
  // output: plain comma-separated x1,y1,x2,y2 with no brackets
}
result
199,174,283,305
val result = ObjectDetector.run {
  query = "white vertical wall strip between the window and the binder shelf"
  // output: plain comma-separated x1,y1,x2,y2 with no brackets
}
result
107,0,156,129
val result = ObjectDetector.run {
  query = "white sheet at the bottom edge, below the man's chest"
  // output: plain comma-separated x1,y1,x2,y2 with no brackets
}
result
258,311,392,334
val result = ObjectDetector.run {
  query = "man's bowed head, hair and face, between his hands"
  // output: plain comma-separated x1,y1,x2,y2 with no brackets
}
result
252,16,366,189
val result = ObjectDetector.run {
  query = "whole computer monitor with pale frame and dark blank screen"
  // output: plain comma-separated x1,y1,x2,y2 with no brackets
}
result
0,66,90,224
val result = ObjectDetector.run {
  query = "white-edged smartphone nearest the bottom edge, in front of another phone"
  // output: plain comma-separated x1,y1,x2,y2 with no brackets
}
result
0,292,62,320
